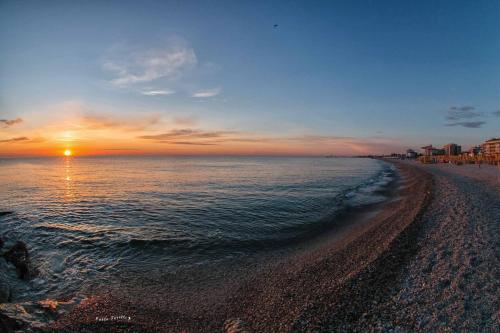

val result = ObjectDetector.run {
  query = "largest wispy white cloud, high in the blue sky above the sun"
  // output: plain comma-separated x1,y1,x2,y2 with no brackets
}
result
103,38,197,87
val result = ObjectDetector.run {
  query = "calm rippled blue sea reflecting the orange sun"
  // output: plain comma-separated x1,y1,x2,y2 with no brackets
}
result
0,157,392,299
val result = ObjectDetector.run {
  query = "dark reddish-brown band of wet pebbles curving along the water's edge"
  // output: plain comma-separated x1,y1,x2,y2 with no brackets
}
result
47,160,430,332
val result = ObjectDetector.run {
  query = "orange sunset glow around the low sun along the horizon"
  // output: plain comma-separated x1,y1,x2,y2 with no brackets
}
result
0,101,406,156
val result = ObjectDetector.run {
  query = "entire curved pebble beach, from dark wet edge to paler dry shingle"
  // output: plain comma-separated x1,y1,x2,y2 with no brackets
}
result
49,162,500,332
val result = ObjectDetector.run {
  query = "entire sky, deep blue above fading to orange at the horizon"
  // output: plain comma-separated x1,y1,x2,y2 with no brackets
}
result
0,0,500,156
